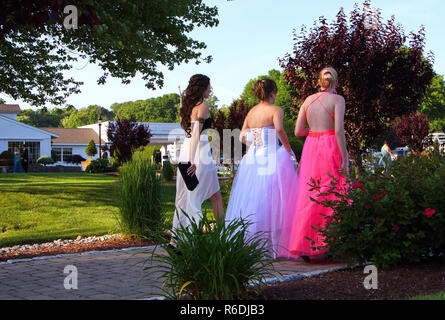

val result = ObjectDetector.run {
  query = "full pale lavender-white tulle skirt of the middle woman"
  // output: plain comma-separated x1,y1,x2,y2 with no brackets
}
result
225,145,297,258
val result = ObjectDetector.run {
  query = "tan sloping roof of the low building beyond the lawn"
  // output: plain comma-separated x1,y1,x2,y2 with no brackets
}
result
39,128,105,145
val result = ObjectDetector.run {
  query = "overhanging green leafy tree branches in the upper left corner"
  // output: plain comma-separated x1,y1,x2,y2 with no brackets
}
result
0,0,219,106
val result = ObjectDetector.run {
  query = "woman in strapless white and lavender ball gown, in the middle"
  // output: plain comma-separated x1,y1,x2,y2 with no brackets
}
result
225,79,297,258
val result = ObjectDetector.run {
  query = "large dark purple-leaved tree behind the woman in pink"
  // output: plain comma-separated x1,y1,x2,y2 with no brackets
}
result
280,1,433,168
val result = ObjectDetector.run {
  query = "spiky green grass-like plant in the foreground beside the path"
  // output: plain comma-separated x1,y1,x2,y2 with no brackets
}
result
144,213,273,300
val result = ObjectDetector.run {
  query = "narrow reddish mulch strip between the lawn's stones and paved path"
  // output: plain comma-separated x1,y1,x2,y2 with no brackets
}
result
0,238,155,262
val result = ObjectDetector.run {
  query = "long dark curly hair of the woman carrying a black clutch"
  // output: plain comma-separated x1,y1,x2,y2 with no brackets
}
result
179,74,210,137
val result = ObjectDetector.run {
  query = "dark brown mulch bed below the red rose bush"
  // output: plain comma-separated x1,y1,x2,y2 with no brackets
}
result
251,261,445,300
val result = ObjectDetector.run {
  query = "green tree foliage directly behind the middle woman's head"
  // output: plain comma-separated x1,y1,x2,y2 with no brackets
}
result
241,69,296,119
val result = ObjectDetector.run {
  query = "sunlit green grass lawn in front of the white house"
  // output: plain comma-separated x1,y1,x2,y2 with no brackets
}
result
0,173,227,247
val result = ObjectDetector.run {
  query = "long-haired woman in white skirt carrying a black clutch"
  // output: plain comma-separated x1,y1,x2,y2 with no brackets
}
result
172,74,223,238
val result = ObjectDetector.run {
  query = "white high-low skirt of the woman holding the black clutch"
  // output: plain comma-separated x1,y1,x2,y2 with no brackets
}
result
173,135,220,229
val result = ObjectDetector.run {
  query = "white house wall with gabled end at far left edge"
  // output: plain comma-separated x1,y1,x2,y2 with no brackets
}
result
0,104,58,161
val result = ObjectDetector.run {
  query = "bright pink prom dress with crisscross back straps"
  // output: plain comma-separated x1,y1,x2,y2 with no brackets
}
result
279,93,346,259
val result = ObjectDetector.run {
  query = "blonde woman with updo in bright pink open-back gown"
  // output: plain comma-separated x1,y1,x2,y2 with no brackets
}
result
279,68,348,261
